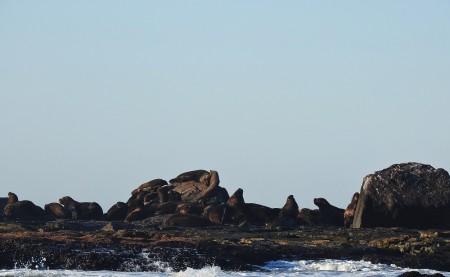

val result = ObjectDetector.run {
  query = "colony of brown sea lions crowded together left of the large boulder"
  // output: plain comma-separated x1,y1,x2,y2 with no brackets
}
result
3,170,355,228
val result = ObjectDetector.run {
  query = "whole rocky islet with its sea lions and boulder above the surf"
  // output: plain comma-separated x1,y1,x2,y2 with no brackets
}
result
0,163,450,271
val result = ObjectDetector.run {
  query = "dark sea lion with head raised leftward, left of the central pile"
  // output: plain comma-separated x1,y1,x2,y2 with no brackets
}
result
59,196,103,220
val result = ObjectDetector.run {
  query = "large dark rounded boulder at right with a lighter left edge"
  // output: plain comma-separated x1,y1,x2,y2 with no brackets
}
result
352,163,450,229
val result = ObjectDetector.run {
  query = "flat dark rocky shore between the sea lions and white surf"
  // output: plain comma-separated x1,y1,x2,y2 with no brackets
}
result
0,220,450,271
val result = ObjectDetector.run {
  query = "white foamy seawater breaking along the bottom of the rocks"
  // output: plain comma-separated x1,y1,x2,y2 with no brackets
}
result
0,260,450,277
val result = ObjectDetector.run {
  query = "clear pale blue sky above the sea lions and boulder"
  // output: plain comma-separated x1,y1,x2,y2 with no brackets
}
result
0,0,450,211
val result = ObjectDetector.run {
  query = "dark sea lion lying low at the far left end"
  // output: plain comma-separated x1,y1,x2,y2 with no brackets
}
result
4,200,48,220
